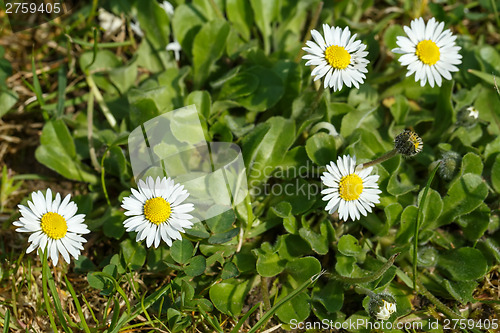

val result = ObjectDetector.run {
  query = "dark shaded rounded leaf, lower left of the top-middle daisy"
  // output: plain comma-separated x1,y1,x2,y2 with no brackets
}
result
236,66,285,112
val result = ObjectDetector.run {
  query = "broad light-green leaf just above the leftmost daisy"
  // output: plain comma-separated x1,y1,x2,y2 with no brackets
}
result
35,119,97,183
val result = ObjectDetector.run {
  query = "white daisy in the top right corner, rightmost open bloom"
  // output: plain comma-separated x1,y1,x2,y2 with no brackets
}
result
392,17,462,87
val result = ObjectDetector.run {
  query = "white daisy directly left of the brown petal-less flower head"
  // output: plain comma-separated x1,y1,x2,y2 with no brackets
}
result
321,155,381,221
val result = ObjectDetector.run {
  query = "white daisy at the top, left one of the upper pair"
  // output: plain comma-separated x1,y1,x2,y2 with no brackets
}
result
302,24,369,91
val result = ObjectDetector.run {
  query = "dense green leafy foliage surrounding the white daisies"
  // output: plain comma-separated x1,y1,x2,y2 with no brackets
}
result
0,0,500,332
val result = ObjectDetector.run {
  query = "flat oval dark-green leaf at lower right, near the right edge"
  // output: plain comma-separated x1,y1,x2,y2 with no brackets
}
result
438,247,488,281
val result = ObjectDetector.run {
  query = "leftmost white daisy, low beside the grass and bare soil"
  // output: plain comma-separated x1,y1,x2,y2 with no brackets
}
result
13,188,90,266
